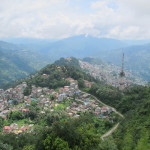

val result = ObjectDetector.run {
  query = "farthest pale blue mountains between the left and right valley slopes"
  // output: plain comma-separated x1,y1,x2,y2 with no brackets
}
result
0,35,127,66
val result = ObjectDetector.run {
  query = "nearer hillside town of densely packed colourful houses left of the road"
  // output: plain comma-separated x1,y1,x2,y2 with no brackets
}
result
0,78,113,134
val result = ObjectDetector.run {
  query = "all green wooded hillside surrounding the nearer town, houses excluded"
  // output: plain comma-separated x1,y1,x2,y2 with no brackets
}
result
0,58,150,150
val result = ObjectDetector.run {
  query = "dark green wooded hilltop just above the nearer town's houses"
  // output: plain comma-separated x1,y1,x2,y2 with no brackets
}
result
22,64,96,89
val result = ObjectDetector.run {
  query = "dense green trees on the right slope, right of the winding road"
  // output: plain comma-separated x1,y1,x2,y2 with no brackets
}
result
89,85,150,150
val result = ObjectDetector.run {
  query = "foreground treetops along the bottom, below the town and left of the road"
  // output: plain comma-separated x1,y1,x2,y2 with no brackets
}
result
0,114,117,150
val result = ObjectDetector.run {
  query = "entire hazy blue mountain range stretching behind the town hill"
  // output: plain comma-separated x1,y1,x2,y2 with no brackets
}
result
0,35,150,86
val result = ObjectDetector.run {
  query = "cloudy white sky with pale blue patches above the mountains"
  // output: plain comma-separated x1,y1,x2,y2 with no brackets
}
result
0,0,150,40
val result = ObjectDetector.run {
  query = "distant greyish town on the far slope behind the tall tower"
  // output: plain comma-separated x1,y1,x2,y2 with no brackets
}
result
79,60,145,87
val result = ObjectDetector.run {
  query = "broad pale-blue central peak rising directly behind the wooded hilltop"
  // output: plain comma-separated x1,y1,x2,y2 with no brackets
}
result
39,35,126,58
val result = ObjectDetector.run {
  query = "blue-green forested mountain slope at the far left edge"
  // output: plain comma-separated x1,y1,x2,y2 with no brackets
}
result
0,41,35,88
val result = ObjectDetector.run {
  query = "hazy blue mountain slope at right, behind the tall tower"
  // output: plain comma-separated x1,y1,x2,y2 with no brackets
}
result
99,44,150,81
